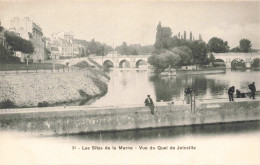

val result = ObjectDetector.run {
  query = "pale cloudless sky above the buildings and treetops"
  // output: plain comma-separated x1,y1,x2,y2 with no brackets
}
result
0,0,260,49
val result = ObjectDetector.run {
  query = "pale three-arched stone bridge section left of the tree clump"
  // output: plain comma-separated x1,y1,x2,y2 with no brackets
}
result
90,55,149,68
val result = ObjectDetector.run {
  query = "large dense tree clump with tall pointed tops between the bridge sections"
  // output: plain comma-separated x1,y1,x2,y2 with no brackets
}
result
148,23,210,69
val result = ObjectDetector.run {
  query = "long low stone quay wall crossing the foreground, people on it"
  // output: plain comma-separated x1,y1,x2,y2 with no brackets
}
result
0,100,260,135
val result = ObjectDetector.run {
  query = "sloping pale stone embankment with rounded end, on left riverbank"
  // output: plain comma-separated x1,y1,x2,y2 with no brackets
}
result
0,69,108,107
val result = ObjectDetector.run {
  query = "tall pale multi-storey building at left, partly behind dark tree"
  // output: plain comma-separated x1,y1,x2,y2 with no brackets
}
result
9,17,46,62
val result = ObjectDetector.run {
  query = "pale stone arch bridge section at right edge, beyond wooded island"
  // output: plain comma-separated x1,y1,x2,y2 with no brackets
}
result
213,53,260,68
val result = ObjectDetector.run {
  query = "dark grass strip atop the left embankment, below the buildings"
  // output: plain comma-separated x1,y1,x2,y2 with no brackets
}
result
0,63,67,71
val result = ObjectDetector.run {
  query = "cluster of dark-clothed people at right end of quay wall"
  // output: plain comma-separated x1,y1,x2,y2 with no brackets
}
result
228,82,256,101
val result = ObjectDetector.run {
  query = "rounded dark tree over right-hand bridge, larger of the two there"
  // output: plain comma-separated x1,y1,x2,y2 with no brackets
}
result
207,37,229,53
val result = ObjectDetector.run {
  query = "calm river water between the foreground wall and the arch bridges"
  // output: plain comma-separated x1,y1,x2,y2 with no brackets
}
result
92,69,260,106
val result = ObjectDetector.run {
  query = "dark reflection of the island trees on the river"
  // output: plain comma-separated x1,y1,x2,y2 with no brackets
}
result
149,75,228,101
